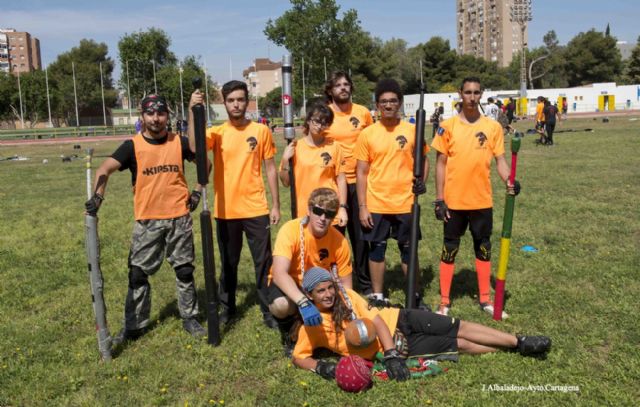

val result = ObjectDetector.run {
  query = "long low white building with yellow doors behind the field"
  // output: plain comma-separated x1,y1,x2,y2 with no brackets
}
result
404,82,640,118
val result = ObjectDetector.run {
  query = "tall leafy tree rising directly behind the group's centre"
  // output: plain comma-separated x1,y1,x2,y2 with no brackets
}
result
264,0,371,98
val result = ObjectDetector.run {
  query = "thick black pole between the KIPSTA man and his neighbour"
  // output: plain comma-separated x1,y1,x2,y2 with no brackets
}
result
191,78,220,346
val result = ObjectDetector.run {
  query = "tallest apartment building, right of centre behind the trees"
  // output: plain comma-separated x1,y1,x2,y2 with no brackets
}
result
456,0,527,66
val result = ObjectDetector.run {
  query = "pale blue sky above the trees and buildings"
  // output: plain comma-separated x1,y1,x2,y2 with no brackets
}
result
0,0,640,82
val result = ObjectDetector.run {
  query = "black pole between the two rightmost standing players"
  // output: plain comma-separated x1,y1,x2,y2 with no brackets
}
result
405,86,427,308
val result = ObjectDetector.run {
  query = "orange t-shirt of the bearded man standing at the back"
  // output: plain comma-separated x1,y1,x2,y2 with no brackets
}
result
325,103,373,184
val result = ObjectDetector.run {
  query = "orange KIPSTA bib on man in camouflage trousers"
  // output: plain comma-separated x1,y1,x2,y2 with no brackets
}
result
133,133,189,220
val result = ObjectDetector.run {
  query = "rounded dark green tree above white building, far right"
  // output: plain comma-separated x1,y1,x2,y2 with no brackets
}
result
564,29,622,86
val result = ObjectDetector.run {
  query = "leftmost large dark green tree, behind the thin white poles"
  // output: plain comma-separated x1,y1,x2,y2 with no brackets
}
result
49,39,117,125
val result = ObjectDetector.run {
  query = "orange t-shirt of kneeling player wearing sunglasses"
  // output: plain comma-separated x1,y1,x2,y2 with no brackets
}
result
269,218,351,287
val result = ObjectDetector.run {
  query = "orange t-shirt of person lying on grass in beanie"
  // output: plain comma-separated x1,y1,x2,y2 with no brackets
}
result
293,288,400,360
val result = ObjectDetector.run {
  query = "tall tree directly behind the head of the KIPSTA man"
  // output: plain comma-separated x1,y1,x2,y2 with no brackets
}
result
118,27,178,106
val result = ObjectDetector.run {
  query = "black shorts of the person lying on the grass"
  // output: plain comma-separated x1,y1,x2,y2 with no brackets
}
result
397,309,460,362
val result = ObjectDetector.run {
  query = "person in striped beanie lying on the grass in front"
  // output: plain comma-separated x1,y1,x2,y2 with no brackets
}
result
293,267,551,380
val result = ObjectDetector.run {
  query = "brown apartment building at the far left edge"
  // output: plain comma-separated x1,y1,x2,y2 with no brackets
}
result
0,29,42,73
